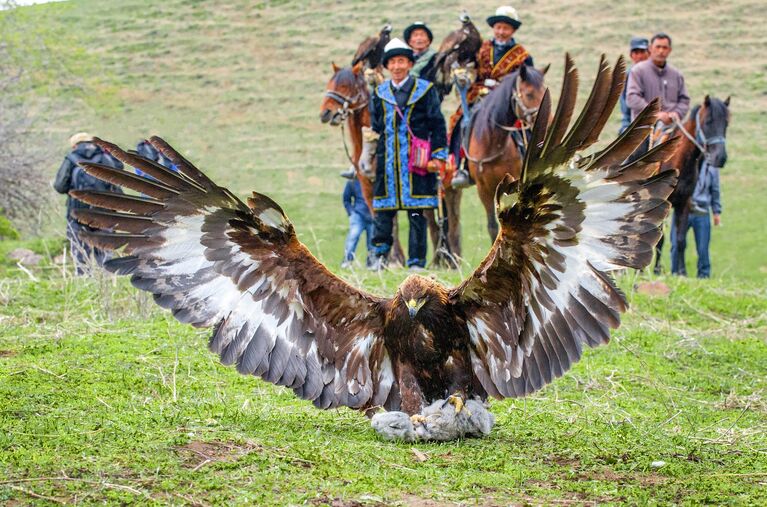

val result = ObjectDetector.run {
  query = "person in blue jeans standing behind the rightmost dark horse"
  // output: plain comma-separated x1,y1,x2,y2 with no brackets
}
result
671,161,722,278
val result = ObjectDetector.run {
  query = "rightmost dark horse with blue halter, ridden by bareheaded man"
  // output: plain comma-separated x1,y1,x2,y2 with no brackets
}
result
654,95,730,276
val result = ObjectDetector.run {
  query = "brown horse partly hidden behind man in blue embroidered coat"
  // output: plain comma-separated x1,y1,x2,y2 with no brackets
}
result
320,61,448,265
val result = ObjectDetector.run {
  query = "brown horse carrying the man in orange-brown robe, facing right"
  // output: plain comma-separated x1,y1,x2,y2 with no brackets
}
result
463,65,548,241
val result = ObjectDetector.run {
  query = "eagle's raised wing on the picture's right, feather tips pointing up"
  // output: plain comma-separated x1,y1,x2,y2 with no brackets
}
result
451,56,676,397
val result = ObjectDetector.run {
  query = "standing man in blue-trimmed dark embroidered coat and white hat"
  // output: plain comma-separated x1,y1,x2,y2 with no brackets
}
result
370,39,447,269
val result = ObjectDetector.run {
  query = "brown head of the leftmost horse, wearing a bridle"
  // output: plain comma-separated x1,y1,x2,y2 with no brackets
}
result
320,62,369,126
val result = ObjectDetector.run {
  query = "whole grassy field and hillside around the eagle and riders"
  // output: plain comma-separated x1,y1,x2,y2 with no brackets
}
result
0,0,767,506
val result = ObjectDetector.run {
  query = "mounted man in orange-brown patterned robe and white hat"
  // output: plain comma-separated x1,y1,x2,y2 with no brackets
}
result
449,5,533,188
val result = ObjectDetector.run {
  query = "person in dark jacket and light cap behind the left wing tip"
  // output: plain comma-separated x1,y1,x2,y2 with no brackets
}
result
53,132,123,275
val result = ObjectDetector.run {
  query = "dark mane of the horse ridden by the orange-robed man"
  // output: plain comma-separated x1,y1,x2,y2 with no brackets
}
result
472,67,543,139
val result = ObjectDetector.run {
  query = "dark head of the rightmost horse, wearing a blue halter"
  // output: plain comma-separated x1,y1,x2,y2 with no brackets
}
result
690,95,730,167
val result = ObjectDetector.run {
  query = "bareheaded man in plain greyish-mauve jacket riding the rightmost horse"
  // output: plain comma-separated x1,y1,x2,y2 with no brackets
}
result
626,33,690,125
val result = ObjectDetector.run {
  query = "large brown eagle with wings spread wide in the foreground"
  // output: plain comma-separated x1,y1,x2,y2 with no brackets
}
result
71,56,676,420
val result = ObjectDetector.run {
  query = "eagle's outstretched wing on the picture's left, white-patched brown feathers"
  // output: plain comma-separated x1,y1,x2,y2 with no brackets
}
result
71,137,399,409
